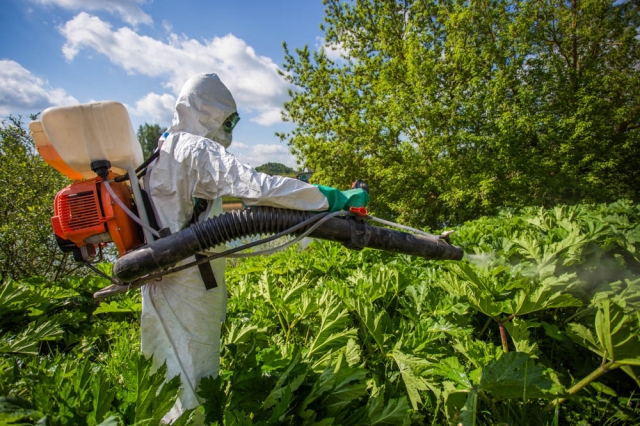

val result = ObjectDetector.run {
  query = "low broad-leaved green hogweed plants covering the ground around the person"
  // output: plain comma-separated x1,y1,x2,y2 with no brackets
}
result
0,202,640,425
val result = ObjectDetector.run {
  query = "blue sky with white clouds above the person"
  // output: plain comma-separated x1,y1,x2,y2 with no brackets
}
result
0,0,344,167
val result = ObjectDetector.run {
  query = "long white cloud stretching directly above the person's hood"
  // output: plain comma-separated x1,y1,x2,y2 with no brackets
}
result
59,12,287,125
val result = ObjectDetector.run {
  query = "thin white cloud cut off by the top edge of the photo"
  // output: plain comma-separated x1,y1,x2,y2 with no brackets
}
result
31,0,153,26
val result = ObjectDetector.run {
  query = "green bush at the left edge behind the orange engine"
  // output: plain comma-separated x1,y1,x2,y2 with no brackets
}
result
0,117,75,282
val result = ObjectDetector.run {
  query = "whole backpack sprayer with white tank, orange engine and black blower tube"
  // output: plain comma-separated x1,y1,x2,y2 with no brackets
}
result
29,101,463,298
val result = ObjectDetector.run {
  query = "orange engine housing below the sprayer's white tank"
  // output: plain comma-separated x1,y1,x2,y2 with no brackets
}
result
51,176,140,256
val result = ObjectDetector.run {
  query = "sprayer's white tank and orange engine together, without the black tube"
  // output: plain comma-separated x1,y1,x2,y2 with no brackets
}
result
29,101,148,262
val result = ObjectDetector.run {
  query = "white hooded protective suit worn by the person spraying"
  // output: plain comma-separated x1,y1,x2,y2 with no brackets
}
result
141,74,329,422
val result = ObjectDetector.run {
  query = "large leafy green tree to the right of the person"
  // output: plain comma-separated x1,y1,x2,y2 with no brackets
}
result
280,0,640,225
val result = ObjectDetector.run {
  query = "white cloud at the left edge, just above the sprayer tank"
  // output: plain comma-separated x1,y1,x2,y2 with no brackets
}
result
0,59,78,115
